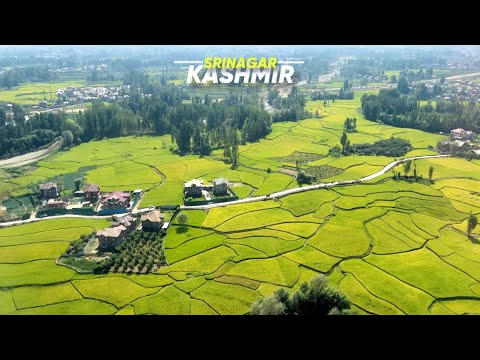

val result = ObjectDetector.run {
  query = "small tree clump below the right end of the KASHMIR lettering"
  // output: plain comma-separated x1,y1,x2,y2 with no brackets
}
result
269,86,310,122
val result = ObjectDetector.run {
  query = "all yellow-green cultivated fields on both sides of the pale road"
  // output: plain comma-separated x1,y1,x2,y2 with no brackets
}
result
0,94,480,314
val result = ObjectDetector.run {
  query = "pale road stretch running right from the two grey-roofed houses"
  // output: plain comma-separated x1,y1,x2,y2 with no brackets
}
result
180,155,450,210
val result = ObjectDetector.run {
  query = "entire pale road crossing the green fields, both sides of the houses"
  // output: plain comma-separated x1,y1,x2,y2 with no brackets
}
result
0,155,450,228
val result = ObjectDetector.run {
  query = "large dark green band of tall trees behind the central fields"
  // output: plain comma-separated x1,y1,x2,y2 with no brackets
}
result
77,86,271,155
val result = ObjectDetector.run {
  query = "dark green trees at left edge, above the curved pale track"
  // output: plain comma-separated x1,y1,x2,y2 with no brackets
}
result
0,104,83,156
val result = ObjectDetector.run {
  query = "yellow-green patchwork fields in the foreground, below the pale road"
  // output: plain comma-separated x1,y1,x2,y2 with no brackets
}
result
0,167,480,314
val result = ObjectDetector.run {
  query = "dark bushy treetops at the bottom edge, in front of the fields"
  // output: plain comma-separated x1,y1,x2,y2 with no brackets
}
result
250,274,352,315
